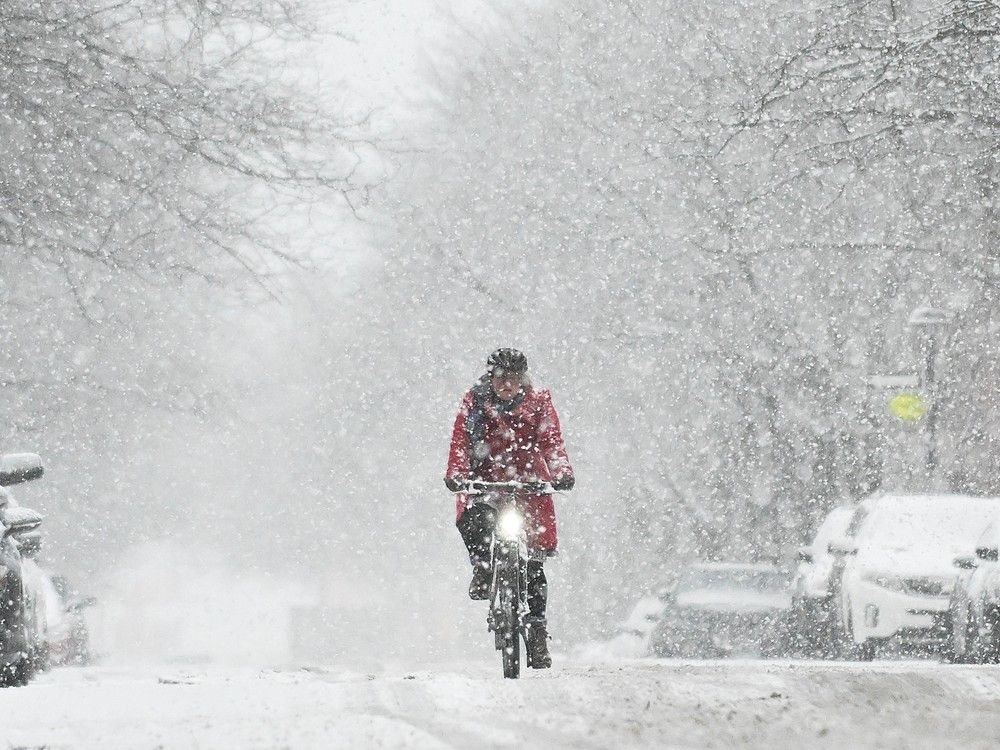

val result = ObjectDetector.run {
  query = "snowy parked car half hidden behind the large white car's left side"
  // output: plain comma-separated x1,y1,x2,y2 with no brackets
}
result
788,505,857,657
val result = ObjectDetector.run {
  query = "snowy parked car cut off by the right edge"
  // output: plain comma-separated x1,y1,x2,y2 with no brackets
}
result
947,524,1000,664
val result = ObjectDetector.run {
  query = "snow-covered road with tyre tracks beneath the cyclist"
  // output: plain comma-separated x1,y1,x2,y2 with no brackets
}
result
0,661,1000,749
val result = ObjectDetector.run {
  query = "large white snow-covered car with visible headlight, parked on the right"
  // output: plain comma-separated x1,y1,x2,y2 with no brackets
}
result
830,495,1000,660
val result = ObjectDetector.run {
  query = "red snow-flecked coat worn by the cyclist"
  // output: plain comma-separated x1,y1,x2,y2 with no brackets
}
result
445,386,573,552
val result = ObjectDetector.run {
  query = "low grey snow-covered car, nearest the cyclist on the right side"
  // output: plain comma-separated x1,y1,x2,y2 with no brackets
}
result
650,562,792,658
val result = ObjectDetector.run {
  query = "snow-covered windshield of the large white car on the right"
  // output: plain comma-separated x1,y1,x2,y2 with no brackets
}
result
859,497,1000,549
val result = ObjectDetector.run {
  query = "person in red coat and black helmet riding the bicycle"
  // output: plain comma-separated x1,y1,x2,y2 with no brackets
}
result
444,349,575,668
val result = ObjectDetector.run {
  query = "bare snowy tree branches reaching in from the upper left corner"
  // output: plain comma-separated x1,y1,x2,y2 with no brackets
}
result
0,0,372,292
